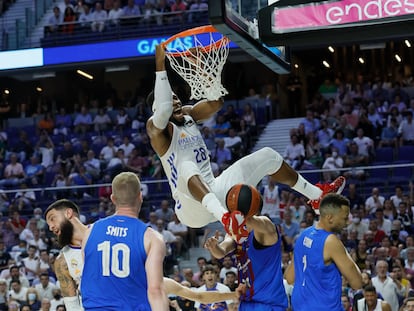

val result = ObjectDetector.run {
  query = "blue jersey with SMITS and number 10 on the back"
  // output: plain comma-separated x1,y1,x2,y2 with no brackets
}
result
81,215,151,311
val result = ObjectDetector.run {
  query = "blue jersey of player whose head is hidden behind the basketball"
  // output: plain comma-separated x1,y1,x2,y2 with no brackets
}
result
236,231,288,311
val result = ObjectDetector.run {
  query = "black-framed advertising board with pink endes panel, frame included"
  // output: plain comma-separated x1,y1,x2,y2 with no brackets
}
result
259,0,414,48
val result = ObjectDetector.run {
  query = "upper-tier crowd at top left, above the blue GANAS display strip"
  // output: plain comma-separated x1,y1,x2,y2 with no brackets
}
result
45,0,208,36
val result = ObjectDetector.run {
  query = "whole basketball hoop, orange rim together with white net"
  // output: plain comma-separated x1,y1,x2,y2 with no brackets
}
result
162,26,230,100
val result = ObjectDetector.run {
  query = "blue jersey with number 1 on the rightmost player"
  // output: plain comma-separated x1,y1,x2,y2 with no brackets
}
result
292,226,343,311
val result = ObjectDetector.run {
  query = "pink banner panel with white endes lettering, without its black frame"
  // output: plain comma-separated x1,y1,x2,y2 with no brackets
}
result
272,0,414,33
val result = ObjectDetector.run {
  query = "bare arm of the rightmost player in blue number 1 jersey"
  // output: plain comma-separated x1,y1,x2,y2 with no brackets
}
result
324,234,362,289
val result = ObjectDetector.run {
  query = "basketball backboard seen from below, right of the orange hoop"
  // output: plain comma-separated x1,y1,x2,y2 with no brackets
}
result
208,0,290,74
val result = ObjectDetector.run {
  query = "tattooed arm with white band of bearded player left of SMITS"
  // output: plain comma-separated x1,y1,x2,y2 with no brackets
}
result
54,254,83,311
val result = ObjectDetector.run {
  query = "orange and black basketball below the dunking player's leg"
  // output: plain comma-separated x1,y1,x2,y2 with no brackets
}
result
226,184,263,218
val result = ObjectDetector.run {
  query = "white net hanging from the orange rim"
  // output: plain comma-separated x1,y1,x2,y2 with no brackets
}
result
166,32,229,100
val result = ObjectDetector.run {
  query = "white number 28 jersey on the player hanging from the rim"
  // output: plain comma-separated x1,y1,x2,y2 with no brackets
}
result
160,115,214,200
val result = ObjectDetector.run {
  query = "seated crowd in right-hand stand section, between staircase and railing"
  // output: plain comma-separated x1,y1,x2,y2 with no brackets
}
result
284,76,414,181
